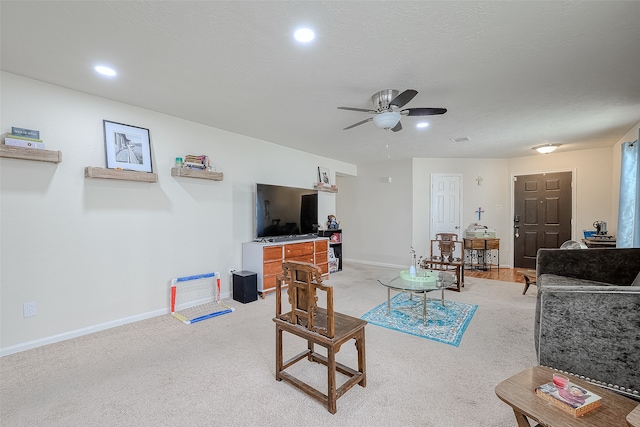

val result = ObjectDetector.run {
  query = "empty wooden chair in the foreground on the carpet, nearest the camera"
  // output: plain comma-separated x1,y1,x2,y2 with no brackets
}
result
273,261,367,414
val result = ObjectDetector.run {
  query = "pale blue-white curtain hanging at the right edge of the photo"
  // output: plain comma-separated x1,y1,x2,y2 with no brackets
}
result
616,131,640,248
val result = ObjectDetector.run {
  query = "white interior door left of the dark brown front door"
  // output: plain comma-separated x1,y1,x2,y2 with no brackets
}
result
430,174,463,240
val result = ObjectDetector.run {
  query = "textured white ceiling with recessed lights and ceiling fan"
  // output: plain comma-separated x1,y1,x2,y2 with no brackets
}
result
0,0,640,164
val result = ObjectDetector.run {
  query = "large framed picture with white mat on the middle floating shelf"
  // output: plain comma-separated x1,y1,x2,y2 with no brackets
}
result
103,120,153,173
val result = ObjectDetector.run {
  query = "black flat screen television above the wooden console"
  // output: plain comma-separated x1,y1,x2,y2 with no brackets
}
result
256,184,318,238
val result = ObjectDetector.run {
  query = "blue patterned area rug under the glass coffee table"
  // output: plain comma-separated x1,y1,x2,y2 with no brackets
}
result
362,292,478,347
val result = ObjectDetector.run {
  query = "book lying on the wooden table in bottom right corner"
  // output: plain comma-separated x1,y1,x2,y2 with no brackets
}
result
535,382,602,417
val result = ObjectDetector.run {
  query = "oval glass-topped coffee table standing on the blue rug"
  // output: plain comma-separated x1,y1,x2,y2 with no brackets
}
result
378,269,455,326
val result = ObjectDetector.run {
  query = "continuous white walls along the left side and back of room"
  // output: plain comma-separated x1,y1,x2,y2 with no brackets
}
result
0,72,640,355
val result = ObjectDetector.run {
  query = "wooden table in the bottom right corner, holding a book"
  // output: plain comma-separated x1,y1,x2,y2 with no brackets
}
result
495,366,640,427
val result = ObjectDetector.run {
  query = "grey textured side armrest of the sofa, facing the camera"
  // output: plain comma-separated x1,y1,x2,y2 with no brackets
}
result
537,285,640,399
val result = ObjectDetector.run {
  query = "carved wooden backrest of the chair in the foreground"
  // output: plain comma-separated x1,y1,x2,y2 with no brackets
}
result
276,261,334,338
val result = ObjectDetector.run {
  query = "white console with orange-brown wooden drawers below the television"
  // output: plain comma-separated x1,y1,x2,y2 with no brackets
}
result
242,238,329,299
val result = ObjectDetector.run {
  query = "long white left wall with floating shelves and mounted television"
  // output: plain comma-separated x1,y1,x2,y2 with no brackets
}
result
0,72,356,354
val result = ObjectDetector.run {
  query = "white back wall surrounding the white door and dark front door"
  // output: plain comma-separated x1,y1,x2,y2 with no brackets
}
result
337,139,639,267
